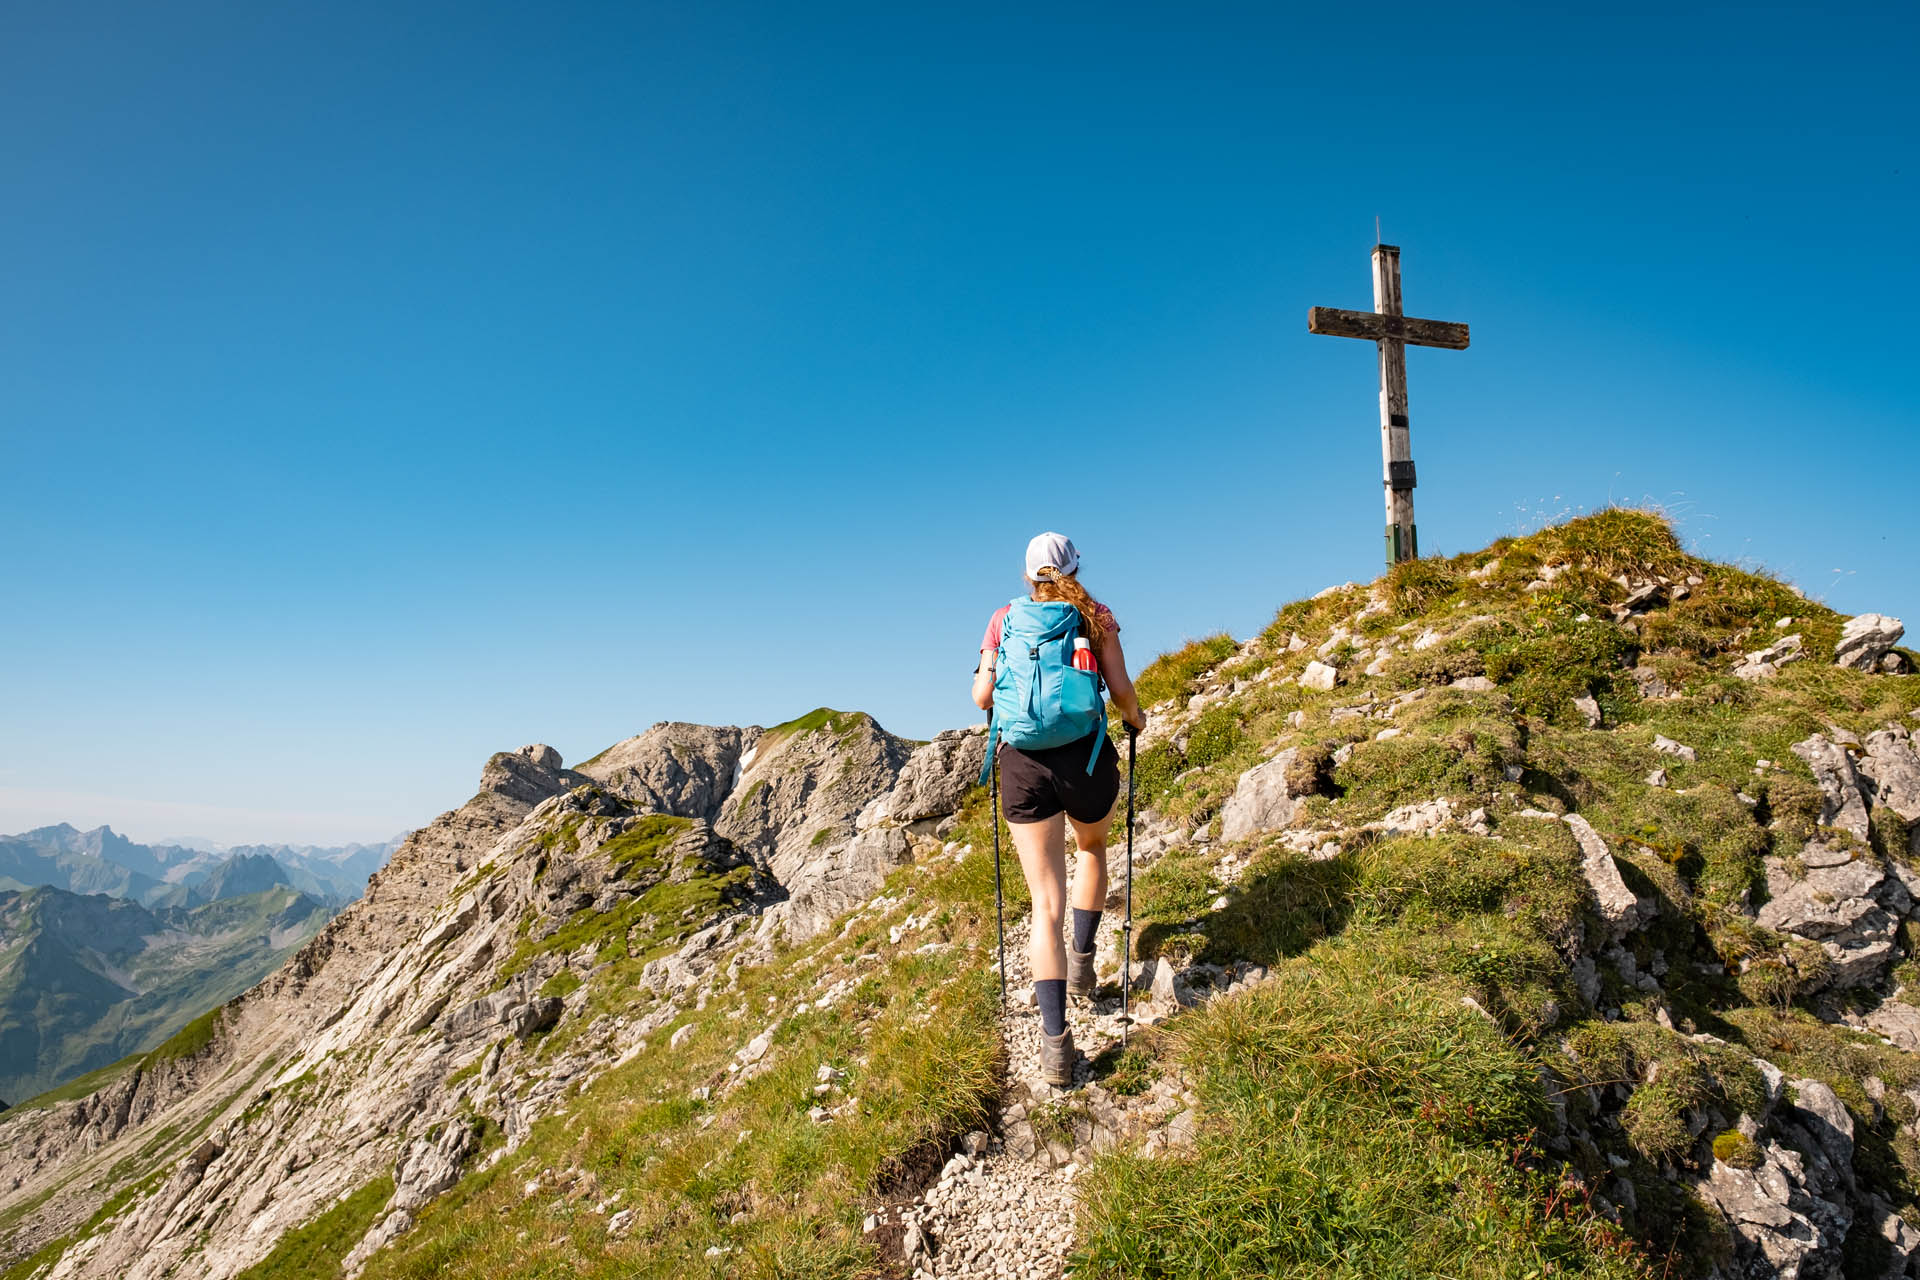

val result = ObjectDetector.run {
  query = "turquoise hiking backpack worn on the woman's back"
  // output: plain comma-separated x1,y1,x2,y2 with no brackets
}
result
979,595,1106,783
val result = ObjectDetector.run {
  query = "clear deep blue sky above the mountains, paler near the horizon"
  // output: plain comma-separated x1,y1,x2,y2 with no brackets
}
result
0,0,1920,841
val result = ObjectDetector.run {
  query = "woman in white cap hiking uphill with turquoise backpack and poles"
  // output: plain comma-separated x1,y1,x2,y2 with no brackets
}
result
973,533,1146,1084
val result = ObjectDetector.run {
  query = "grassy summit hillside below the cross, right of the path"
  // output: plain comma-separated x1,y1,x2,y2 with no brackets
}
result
1083,510,1920,1276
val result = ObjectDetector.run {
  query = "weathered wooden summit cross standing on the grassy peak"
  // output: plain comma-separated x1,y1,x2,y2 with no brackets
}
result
1308,244,1467,568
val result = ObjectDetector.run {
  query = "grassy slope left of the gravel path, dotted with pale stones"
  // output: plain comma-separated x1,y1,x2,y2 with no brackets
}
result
355,804,1000,1280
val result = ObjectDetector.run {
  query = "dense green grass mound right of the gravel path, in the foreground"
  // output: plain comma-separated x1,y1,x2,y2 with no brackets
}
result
1073,952,1645,1280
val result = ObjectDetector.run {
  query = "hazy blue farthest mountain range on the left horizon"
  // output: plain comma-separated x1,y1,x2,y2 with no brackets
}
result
0,823,403,908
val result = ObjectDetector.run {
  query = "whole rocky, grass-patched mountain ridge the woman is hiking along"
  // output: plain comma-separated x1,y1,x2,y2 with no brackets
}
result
0,512,1920,1280
